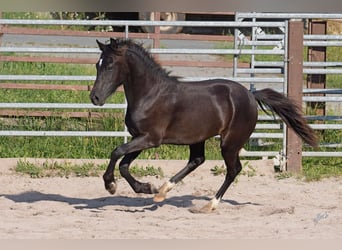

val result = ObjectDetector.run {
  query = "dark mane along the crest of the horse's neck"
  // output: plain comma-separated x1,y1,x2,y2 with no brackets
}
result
112,38,179,82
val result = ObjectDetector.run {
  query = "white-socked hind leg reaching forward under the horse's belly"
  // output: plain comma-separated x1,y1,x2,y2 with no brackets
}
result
153,142,205,202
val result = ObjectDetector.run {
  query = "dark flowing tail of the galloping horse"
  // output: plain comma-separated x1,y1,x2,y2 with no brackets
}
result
253,88,318,147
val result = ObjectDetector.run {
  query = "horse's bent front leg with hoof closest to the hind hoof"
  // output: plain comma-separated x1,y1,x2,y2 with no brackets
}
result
119,151,158,194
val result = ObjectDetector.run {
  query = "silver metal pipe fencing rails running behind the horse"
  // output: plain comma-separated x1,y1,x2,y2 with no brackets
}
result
0,13,342,160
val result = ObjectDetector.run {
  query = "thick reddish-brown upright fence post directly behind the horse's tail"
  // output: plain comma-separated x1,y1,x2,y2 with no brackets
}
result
286,19,304,173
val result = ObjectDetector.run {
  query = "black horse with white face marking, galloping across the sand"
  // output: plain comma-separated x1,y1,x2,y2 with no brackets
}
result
90,39,317,212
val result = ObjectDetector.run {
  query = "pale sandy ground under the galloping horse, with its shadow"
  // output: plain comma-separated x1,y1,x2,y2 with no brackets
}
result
0,159,342,239
